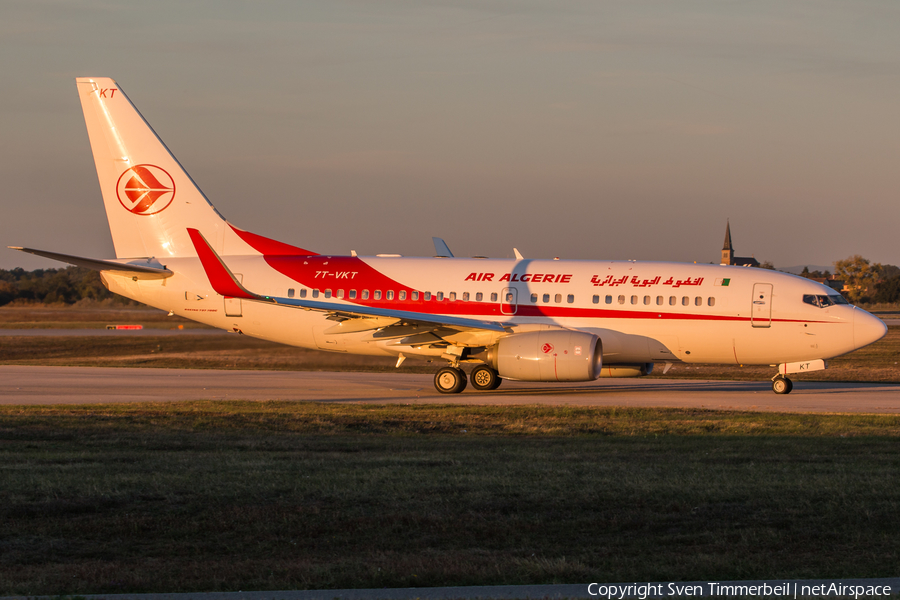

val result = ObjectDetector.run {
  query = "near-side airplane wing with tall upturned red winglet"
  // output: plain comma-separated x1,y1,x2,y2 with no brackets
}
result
188,229,507,333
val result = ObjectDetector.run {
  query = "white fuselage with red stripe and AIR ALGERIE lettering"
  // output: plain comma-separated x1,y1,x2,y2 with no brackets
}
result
104,256,886,365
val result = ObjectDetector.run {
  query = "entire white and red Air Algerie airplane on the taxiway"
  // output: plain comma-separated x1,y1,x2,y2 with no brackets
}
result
10,77,887,394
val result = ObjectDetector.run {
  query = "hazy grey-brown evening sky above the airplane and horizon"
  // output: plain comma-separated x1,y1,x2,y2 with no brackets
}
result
0,0,900,269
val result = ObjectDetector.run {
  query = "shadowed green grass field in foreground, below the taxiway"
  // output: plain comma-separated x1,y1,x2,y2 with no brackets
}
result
0,402,900,595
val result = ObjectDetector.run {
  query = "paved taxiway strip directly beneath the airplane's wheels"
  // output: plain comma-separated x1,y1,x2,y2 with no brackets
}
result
0,366,900,413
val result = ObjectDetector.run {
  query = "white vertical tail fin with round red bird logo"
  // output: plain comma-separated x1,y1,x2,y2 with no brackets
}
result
76,77,230,259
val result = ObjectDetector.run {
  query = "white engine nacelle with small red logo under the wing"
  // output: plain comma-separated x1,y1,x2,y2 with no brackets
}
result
490,329,603,381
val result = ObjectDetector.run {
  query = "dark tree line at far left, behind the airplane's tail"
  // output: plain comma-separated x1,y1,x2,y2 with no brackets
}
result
0,267,132,306
